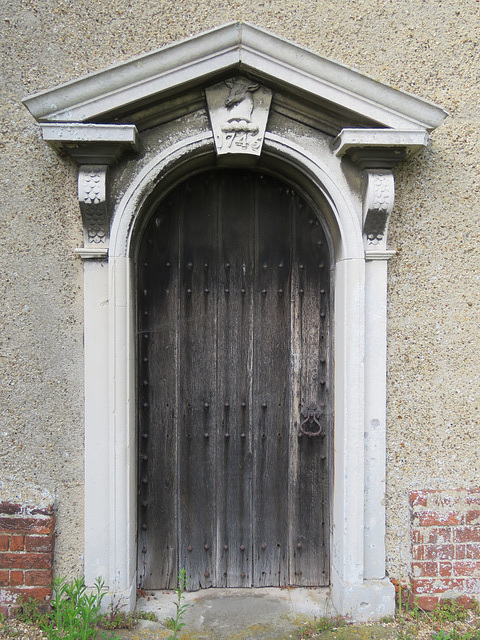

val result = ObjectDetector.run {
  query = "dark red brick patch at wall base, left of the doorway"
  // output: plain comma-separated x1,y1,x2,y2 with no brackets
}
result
0,502,55,616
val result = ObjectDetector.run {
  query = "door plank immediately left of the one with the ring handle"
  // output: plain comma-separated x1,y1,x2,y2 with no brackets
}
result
252,176,291,586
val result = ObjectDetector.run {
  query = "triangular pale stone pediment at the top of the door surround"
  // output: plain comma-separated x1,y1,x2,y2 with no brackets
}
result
24,22,446,135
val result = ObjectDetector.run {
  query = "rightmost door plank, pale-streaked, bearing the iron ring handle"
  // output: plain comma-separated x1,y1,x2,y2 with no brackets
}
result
289,195,331,586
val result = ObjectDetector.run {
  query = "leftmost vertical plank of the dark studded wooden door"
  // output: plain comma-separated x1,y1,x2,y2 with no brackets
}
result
137,195,178,589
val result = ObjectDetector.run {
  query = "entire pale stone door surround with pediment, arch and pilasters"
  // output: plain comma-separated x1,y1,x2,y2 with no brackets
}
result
24,23,446,620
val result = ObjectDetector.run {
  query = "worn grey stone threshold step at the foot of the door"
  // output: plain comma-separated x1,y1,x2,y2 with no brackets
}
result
137,587,336,640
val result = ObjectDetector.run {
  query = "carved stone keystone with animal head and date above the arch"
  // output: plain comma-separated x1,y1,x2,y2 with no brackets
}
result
205,77,272,156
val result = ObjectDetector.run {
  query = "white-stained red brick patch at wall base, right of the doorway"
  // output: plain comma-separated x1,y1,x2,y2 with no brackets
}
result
410,489,480,610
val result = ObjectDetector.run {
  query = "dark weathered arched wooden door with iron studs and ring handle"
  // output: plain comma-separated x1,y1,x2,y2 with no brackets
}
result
137,170,332,590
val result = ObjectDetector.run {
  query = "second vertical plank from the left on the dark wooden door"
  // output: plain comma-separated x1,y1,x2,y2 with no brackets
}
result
178,174,218,591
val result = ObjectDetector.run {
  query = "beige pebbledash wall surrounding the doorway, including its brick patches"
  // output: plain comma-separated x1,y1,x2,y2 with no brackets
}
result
0,0,480,606
